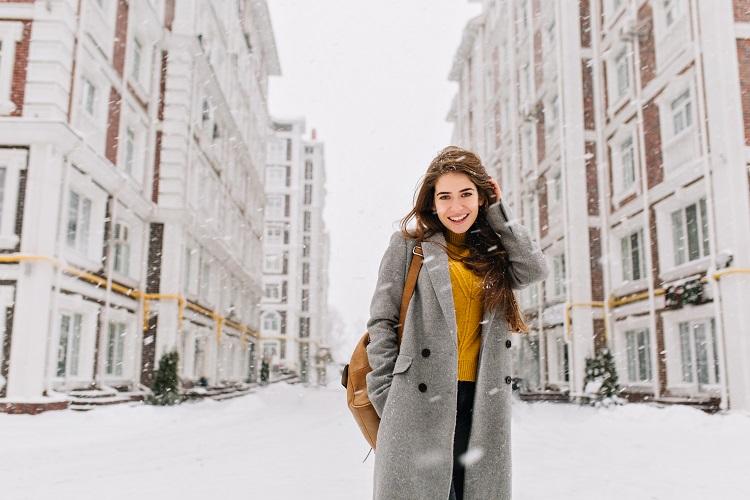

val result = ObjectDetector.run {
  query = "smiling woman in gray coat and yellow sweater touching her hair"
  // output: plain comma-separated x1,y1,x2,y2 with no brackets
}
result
367,147,547,500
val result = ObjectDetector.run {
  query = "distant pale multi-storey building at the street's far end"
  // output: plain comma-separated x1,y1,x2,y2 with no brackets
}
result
261,119,329,382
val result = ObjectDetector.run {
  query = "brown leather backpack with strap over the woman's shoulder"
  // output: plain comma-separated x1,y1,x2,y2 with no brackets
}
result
341,246,423,449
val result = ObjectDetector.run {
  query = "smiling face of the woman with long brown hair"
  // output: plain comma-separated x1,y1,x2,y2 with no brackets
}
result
433,172,479,234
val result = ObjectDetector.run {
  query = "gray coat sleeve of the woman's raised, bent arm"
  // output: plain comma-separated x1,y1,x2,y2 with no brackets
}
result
487,200,549,289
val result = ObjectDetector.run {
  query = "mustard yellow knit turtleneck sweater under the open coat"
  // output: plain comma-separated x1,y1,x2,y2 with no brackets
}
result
445,230,484,381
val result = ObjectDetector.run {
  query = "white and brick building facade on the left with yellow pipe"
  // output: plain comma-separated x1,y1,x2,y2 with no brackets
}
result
0,0,280,412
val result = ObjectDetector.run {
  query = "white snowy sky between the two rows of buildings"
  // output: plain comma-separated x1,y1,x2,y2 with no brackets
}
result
268,0,480,338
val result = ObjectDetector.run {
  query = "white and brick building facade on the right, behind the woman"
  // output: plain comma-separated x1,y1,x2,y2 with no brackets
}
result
448,0,750,409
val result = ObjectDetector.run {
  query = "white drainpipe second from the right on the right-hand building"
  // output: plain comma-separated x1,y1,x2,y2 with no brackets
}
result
627,0,661,399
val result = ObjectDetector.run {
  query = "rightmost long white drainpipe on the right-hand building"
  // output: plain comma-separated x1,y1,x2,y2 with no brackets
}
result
689,0,729,410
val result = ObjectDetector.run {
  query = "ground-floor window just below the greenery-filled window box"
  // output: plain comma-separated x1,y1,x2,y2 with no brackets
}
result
679,318,719,385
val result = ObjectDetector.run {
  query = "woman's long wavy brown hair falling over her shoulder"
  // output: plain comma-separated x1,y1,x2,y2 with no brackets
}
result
401,146,529,332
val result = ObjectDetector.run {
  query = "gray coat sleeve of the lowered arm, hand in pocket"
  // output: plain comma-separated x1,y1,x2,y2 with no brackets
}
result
367,232,407,416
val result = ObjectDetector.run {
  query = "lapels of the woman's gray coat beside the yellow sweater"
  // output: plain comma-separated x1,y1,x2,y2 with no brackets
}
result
422,232,495,342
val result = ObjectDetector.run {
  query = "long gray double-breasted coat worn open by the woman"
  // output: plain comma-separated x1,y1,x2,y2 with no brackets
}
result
367,203,547,500
